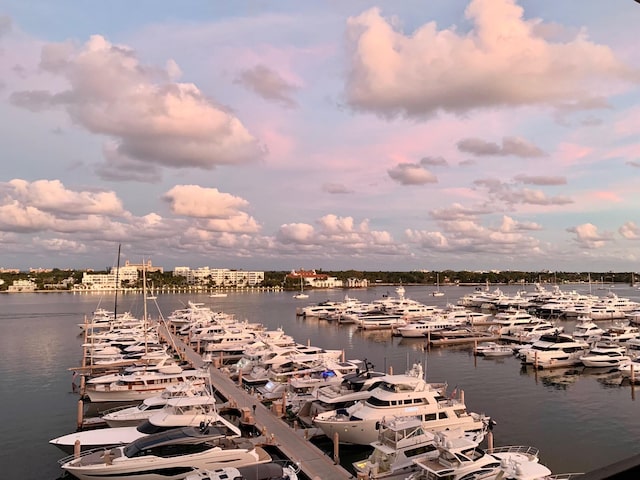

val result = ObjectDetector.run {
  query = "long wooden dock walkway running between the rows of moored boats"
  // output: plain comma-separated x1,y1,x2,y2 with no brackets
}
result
160,327,354,480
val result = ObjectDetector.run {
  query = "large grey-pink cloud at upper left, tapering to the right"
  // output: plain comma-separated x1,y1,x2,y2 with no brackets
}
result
10,35,265,178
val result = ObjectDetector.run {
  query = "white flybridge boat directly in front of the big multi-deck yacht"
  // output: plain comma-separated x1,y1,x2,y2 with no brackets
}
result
352,418,485,480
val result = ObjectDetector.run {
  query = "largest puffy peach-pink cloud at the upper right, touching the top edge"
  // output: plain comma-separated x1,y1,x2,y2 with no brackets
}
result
345,0,638,117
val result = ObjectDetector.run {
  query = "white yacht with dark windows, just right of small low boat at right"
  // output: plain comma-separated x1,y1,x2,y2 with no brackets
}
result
520,333,590,368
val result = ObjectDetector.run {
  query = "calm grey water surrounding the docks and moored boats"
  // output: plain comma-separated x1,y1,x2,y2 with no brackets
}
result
0,286,640,480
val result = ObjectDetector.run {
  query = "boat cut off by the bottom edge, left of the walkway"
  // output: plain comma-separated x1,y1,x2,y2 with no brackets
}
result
185,462,300,480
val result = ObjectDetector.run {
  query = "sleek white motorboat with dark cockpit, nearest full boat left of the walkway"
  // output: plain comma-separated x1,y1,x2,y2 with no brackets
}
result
59,425,271,480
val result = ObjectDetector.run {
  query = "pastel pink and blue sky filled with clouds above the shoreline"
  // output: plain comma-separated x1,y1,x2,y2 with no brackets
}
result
0,0,640,272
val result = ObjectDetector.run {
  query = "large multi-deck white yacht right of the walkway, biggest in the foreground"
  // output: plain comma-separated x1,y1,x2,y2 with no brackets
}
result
313,364,485,445
